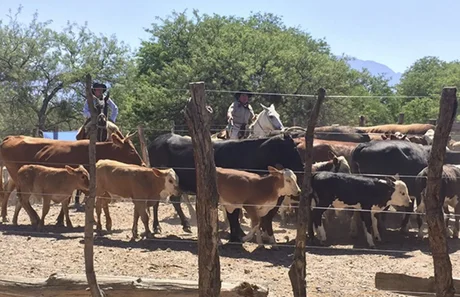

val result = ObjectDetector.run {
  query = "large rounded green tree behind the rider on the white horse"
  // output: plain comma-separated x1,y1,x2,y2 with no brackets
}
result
132,10,391,133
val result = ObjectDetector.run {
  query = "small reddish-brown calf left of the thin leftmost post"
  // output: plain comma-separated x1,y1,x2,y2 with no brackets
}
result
13,165,89,230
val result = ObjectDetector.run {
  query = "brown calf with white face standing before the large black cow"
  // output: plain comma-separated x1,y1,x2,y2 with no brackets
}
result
216,166,300,245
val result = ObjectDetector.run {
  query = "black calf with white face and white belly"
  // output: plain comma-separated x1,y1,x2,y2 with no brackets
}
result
311,171,411,247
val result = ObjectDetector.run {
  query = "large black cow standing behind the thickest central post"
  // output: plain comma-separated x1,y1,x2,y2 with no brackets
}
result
148,133,303,242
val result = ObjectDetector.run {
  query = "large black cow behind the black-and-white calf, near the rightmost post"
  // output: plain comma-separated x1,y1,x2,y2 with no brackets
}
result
350,140,460,232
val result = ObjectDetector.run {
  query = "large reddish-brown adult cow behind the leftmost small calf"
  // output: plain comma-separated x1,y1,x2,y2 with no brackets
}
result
0,133,145,222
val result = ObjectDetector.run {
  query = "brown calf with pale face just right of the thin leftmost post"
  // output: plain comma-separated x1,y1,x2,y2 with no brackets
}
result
96,160,180,239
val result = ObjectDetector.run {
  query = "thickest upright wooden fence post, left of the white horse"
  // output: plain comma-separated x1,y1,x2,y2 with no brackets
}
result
185,82,221,297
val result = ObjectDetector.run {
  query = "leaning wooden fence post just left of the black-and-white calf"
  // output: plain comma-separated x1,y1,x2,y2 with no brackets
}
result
289,88,326,297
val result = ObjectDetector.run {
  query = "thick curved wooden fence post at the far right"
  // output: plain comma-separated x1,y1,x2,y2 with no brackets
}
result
425,88,458,297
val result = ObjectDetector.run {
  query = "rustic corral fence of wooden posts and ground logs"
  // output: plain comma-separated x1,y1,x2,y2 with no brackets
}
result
0,76,460,297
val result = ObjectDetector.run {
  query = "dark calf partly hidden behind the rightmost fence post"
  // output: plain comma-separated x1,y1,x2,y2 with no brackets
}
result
415,164,460,239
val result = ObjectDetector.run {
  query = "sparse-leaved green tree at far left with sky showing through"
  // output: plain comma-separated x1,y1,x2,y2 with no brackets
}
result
0,7,130,134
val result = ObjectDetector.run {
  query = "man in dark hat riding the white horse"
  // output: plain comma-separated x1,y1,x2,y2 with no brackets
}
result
227,90,255,139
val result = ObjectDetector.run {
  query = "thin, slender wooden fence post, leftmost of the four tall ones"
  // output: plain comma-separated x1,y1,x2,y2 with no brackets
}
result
84,74,105,297
